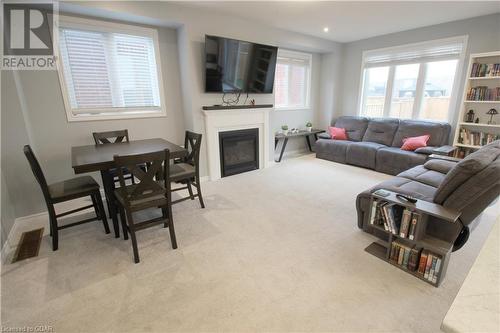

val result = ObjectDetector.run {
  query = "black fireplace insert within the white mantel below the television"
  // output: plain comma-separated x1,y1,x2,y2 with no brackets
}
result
219,128,259,177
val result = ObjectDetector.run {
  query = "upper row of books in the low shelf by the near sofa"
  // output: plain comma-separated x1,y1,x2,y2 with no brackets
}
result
370,200,422,240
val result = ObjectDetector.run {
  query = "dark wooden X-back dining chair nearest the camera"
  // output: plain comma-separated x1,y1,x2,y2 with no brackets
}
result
114,149,177,263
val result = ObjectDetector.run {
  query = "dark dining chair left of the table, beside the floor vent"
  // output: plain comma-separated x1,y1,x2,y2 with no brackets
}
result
23,145,109,251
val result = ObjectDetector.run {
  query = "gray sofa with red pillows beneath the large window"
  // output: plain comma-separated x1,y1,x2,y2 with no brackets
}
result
315,116,451,175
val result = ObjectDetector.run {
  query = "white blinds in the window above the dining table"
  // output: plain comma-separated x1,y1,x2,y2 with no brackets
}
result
59,28,160,114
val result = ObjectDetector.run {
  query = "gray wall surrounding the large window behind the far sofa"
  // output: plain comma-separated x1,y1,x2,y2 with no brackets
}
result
335,14,500,124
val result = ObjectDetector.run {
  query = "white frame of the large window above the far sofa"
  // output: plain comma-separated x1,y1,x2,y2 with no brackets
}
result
357,35,468,123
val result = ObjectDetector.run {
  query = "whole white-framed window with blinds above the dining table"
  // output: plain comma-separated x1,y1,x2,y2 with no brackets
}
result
58,17,165,121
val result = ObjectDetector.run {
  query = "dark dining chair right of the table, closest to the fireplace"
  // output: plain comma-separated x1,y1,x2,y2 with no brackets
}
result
170,131,205,208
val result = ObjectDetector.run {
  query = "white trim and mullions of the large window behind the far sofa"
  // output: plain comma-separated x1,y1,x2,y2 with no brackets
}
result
357,35,469,123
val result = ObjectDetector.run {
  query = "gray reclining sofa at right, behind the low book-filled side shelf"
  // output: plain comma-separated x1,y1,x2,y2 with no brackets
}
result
356,140,500,249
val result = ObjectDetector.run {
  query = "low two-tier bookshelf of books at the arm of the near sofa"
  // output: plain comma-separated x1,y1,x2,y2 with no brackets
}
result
365,190,461,287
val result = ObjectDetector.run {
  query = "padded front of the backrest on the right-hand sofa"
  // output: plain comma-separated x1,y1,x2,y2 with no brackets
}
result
434,140,500,204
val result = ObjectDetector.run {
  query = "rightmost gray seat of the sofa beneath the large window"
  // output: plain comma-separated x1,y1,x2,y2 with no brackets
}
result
375,147,427,175
